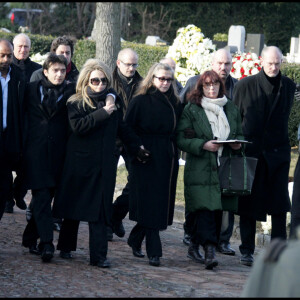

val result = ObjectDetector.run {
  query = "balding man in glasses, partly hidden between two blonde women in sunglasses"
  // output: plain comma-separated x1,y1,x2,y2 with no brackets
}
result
108,48,143,240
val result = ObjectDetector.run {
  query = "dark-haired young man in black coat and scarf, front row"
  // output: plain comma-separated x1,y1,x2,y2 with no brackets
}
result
22,53,75,262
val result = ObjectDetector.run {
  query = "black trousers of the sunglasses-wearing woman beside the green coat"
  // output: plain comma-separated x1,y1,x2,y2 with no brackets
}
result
128,223,162,258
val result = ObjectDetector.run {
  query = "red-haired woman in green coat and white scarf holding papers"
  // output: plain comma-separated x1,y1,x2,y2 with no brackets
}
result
177,71,243,269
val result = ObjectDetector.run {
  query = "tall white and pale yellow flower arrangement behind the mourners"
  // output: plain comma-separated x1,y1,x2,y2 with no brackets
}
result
166,25,216,86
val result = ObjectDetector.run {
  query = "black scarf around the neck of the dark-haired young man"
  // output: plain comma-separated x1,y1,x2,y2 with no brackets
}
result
41,73,66,115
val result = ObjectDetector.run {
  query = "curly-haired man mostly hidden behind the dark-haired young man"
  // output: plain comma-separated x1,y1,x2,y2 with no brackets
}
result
30,35,79,231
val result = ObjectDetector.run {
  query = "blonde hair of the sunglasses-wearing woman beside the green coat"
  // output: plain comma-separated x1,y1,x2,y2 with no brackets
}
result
134,63,179,101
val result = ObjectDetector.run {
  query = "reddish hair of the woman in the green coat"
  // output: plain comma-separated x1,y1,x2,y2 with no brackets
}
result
187,70,225,106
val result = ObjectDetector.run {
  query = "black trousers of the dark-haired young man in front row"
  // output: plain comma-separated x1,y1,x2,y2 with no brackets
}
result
22,188,55,248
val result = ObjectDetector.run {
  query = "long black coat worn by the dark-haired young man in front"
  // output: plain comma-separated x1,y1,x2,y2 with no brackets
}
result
24,81,75,189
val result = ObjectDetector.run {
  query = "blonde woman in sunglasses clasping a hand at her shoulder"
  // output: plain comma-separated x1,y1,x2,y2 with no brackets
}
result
53,59,146,268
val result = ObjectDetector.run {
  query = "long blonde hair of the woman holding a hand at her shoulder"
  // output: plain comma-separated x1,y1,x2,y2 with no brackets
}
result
68,58,112,109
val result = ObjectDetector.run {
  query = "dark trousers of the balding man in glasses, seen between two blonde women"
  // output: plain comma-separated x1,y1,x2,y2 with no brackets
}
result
112,149,130,223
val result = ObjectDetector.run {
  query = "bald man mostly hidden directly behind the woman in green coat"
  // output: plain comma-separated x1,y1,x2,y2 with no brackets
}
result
180,48,238,255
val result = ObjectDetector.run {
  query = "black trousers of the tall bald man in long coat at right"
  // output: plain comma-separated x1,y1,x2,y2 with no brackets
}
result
239,213,287,254
